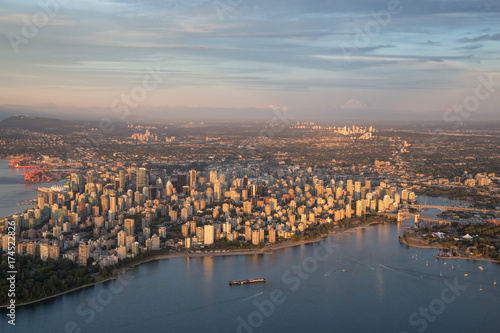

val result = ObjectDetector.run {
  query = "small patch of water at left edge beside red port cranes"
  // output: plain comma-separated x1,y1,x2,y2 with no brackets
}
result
0,160,64,217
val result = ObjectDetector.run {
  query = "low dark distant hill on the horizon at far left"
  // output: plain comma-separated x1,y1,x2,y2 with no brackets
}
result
0,116,81,132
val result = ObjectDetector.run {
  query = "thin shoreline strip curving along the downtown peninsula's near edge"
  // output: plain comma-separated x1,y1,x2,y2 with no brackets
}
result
0,221,382,309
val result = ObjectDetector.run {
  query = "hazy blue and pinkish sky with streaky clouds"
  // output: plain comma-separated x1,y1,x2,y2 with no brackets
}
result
0,0,500,121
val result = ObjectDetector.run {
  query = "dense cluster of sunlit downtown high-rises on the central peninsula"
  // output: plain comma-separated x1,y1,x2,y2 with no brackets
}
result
0,162,415,266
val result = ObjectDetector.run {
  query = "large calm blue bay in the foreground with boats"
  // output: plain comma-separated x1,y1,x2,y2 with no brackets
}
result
0,221,500,332
